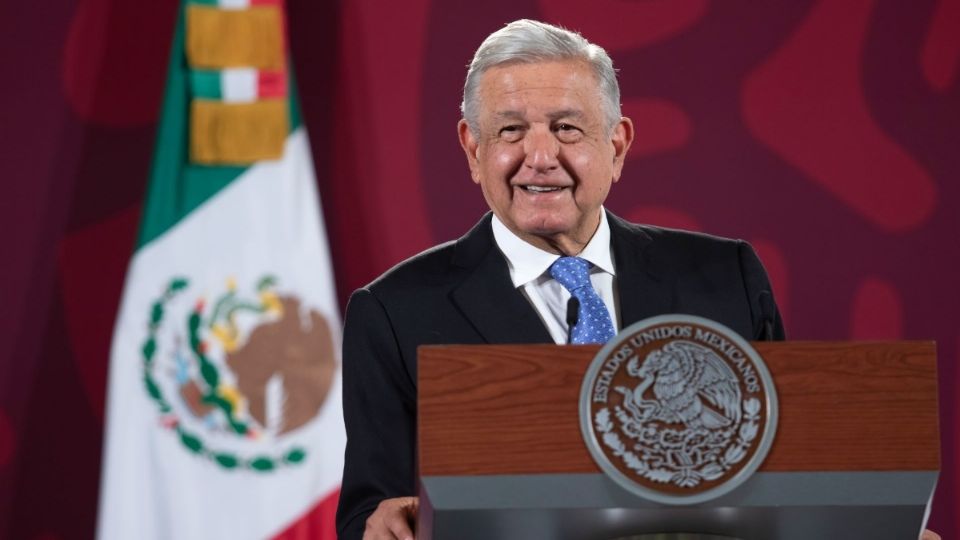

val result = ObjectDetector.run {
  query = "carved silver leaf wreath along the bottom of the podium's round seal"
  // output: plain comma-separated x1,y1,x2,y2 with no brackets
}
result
594,398,760,487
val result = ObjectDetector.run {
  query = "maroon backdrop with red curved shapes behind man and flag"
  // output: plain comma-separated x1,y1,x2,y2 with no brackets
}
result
0,0,960,539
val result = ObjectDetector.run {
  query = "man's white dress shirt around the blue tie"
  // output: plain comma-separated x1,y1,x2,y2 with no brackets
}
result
493,209,620,345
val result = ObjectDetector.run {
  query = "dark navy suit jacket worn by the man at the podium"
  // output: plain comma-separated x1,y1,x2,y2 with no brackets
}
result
337,213,784,540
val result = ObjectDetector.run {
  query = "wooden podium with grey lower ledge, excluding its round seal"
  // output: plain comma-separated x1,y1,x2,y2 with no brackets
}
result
417,342,940,540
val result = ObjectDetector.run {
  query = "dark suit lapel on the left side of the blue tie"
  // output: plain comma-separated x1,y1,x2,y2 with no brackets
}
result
450,214,553,343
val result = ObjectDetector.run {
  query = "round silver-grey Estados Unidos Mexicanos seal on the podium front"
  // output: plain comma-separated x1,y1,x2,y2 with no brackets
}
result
580,315,777,504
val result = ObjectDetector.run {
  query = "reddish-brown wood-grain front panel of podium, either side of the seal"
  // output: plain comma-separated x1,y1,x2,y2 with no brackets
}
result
418,341,940,475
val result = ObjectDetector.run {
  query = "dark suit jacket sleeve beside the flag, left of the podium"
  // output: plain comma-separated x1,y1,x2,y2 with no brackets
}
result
337,289,417,540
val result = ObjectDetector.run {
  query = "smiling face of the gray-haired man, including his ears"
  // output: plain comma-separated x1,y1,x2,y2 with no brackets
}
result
458,61,633,255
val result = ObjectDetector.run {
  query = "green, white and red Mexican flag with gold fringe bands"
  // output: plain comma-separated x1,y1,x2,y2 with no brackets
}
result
98,0,345,540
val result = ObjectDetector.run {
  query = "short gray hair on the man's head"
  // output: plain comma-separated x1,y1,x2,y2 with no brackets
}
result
460,19,620,135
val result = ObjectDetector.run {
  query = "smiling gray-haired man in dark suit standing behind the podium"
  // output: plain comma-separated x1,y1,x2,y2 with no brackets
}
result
337,21,783,539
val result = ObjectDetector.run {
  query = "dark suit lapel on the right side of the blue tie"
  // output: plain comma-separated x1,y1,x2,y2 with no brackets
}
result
607,212,674,328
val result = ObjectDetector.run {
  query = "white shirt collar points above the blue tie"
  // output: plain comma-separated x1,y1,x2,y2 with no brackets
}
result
492,208,617,287
